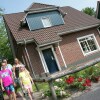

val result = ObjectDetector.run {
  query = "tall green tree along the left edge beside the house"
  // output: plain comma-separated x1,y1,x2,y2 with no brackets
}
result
0,8,13,61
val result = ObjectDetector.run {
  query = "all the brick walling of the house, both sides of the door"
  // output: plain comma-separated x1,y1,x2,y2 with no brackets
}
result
18,28,100,74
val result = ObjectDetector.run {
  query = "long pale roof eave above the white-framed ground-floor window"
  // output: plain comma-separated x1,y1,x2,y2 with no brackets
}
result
58,23,100,35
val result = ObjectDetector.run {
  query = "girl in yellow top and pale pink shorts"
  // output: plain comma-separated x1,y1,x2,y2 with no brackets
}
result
19,65,33,100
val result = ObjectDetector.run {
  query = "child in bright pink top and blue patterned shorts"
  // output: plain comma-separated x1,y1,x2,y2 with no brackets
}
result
0,63,16,100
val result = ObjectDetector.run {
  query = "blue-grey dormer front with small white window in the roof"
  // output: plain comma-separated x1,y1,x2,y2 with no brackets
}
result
26,11,64,31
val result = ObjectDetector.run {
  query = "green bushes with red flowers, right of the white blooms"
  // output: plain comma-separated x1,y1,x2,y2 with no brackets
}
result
65,64,100,90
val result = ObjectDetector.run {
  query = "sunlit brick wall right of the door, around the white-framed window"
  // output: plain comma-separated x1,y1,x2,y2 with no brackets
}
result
56,28,100,66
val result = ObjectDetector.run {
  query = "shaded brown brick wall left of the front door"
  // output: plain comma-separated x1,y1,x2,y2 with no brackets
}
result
17,43,44,75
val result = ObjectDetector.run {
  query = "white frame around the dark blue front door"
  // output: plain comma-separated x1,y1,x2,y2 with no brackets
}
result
38,45,61,73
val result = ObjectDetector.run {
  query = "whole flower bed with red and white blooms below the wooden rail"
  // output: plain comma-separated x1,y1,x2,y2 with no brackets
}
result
44,64,100,98
